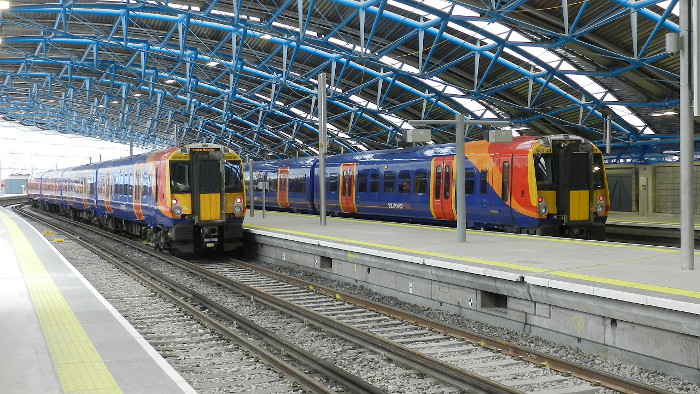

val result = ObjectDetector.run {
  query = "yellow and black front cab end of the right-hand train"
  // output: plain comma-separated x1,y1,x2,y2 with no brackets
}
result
532,136,609,239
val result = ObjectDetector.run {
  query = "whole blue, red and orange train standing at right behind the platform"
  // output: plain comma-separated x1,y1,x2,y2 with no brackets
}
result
246,136,609,238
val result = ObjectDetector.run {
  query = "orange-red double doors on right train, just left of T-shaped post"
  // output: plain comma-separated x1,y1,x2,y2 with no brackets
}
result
430,156,455,220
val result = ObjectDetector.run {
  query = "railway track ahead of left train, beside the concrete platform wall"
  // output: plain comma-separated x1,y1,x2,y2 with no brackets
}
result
13,205,676,394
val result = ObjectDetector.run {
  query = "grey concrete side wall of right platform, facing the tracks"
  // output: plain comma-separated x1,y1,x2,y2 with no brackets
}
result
246,230,700,383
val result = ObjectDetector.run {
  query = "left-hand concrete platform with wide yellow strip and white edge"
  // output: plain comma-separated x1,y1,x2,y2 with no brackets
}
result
0,207,195,394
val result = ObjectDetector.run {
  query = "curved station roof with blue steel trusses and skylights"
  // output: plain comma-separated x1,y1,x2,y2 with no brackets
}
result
0,0,680,159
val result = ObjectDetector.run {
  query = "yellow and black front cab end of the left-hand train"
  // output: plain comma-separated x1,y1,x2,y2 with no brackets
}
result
168,144,245,253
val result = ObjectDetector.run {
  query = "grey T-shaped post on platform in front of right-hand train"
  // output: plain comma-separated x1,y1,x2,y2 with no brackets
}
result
408,114,512,242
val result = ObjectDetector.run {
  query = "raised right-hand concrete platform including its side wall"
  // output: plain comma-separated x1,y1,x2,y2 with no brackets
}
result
245,210,700,382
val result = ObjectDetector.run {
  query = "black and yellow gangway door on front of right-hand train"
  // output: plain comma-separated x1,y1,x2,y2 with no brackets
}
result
555,141,592,222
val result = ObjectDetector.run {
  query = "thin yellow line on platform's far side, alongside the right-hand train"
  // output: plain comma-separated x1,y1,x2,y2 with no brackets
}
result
268,212,700,255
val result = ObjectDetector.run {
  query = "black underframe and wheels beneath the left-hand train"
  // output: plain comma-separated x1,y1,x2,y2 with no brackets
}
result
32,201,243,254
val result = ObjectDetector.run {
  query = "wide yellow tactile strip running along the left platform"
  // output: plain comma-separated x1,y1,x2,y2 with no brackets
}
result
0,211,122,393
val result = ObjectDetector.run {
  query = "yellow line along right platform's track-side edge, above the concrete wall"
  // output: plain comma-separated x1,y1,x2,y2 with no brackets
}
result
246,224,700,298
